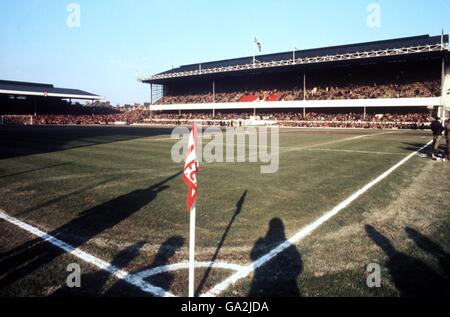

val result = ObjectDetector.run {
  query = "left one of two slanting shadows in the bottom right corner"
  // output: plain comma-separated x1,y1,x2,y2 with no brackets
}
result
365,225,448,297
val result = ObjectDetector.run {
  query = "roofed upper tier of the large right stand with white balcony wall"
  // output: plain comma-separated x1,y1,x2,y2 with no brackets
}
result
140,35,450,116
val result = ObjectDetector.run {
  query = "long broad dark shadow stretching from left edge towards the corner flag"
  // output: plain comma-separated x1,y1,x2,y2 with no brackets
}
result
0,173,181,287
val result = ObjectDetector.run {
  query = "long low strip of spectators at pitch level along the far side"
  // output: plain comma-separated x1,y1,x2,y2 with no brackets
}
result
2,111,430,129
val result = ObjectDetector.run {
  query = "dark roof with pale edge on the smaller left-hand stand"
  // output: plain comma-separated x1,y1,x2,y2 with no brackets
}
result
0,80,103,100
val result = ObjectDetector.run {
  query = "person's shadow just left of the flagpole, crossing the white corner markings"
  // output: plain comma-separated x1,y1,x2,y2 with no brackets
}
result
104,236,184,297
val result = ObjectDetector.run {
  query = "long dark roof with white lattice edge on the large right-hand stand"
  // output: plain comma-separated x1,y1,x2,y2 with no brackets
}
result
140,34,450,84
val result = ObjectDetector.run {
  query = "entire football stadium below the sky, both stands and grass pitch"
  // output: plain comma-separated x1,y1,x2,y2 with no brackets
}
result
0,30,450,297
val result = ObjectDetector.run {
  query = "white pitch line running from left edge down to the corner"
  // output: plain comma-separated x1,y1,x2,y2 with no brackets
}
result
0,209,174,297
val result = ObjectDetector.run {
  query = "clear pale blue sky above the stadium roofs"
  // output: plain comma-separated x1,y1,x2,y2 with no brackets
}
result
0,0,450,104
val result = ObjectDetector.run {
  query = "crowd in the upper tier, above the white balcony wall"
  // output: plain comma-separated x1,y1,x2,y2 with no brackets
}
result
157,80,441,105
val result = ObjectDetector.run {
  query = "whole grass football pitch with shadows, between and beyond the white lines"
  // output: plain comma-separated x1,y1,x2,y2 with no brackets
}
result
0,127,450,296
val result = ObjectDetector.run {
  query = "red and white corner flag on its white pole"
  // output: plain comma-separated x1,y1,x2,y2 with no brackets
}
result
183,123,198,297
